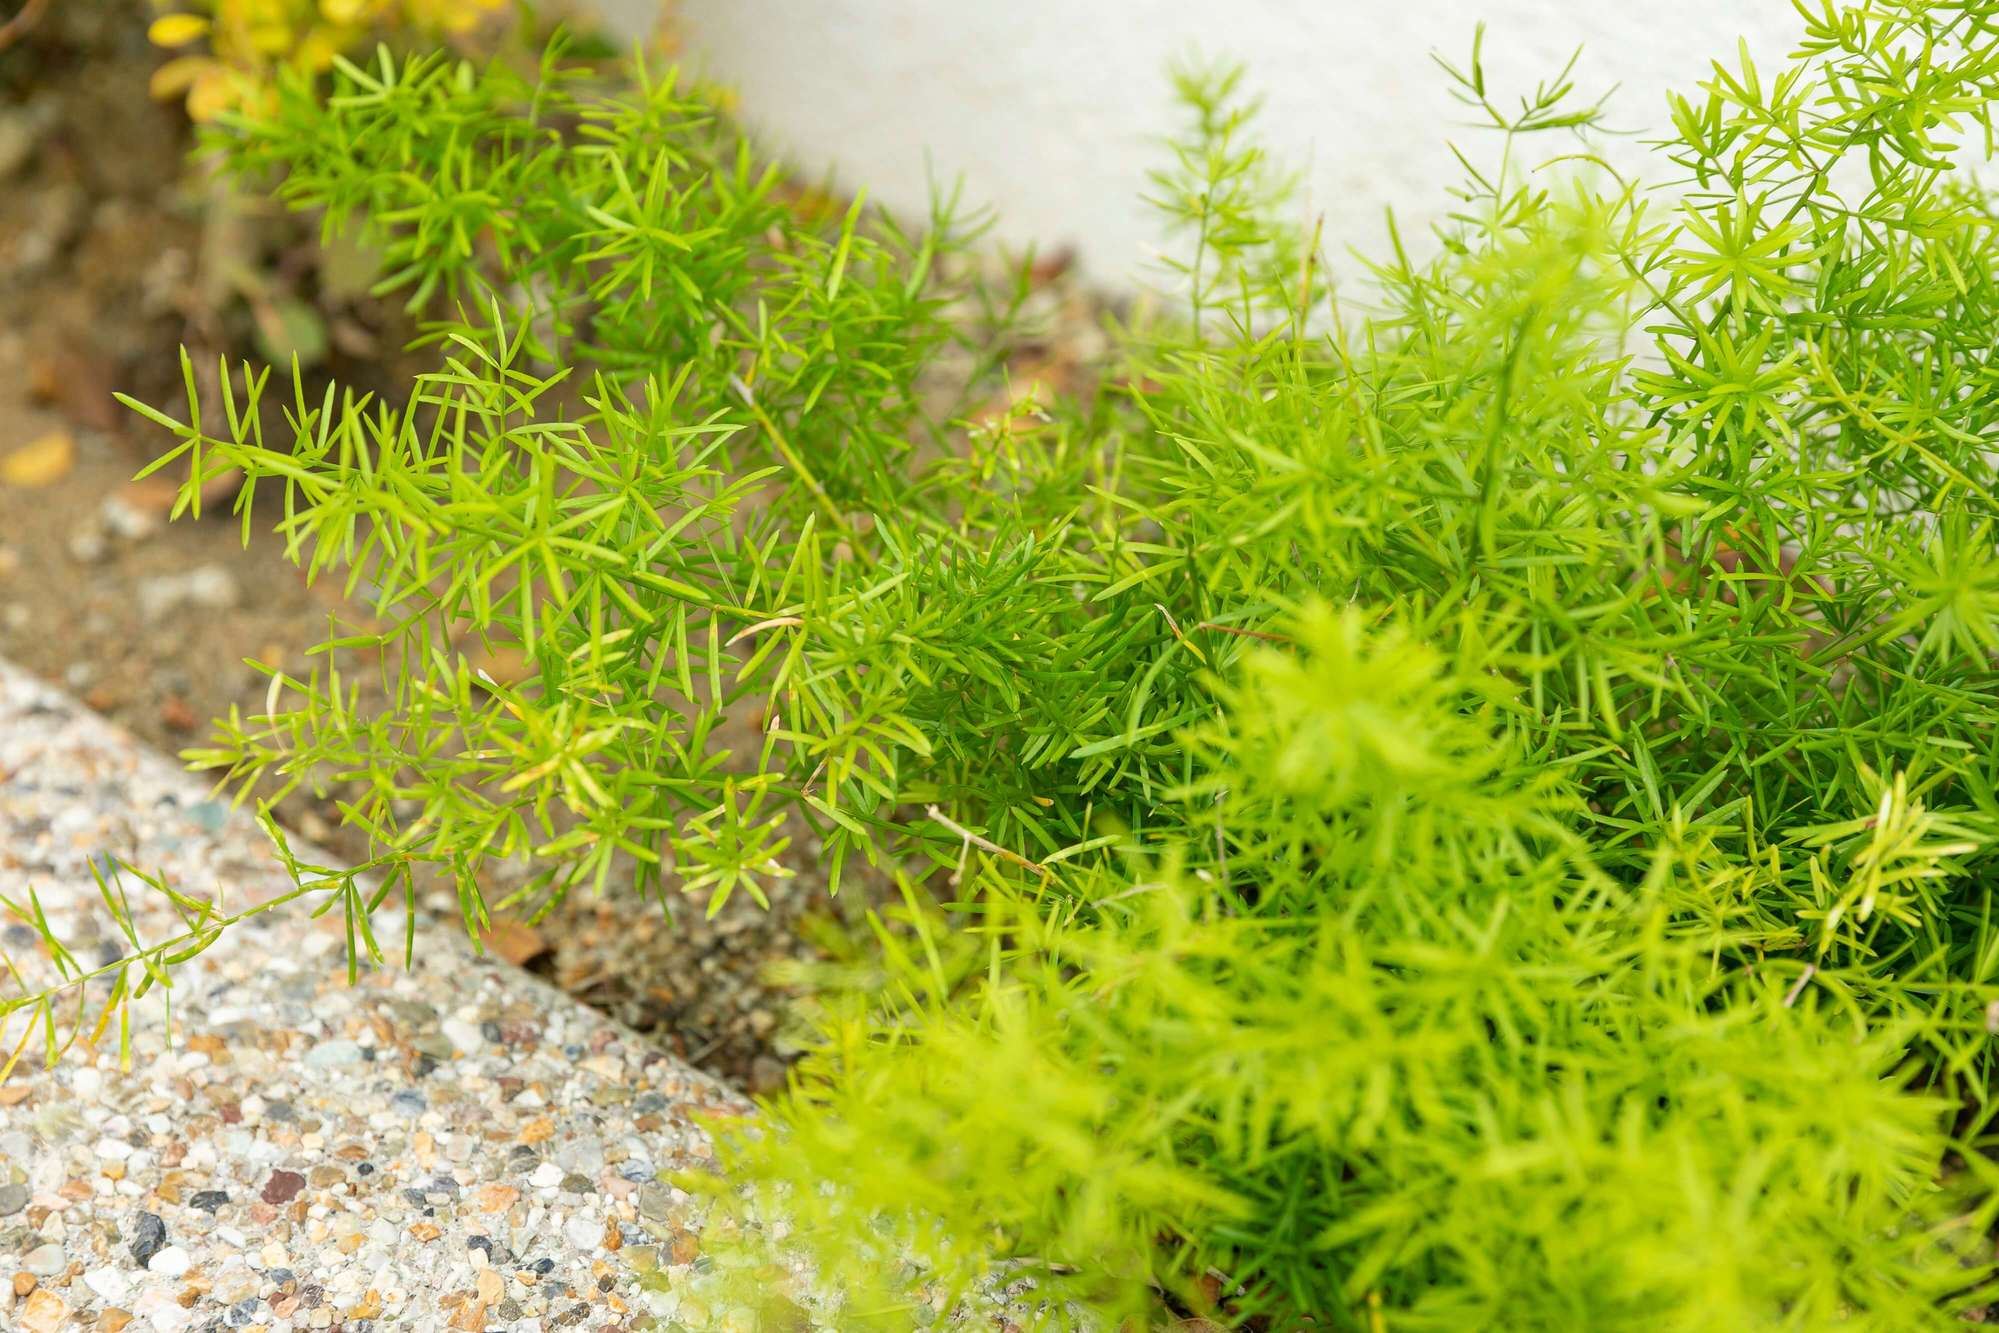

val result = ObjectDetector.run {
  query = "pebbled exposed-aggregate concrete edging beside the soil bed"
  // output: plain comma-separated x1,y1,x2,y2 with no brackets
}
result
0,664,787,1333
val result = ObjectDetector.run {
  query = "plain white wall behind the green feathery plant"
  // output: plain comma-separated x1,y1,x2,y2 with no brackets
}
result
615,0,1797,278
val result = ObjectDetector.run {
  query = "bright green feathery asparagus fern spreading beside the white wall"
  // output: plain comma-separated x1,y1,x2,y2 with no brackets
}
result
46,0,1999,1331
